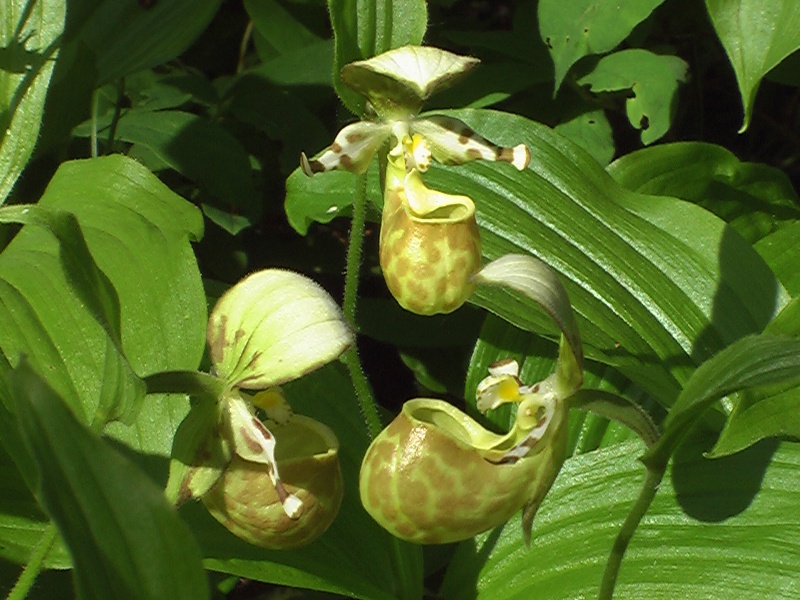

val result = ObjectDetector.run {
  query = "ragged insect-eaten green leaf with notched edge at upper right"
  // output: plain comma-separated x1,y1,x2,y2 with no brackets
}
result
578,48,689,145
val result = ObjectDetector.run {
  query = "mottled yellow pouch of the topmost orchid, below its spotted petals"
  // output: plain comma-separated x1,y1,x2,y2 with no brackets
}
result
380,136,481,315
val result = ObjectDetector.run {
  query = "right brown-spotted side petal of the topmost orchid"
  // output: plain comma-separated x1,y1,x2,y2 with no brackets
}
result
412,115,531,171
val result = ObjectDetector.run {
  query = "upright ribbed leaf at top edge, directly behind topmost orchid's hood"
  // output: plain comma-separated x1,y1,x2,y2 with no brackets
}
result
328,0,428,117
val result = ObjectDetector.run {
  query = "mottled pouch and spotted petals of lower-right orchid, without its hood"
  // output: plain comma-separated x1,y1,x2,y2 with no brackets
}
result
359,362,568,544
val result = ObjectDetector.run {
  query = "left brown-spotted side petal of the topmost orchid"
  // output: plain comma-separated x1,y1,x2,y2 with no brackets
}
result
300,121,392,177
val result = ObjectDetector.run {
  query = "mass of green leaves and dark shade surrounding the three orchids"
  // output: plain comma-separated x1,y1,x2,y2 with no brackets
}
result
0,0,800,599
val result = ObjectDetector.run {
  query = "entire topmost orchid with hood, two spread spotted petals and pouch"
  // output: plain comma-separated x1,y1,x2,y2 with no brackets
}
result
300,46,530,315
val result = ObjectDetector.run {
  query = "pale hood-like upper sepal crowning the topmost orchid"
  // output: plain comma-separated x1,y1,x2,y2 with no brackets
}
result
341,46,480,121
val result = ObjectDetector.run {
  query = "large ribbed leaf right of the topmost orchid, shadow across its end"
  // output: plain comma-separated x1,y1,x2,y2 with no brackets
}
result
426,110,788,406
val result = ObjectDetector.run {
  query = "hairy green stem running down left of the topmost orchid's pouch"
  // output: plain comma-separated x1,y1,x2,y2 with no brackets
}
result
342,173,381,438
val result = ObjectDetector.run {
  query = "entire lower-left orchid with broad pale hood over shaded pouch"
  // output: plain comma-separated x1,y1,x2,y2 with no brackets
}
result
167,269,353,548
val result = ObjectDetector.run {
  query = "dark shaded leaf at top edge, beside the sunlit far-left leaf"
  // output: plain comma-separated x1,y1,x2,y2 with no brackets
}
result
66,0,222,86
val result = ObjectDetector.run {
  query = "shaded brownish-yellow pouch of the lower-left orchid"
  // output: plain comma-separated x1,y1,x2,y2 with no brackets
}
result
202,415,344,549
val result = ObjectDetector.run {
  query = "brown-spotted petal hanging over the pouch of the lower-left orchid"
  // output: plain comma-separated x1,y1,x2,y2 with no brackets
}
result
225,397,303,519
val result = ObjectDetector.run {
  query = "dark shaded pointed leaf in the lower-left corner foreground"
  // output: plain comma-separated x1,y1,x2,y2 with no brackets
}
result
12,363,208,600
